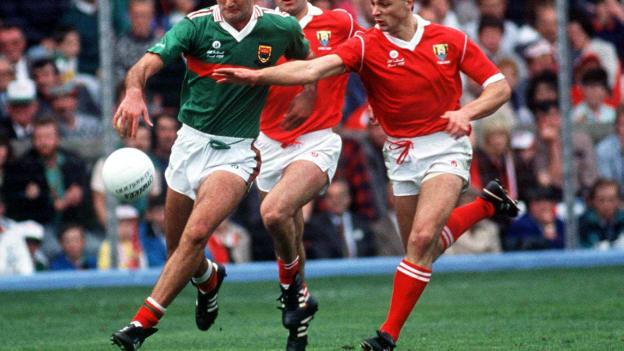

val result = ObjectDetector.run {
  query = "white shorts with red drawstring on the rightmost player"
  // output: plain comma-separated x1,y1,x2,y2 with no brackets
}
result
383,132,472,196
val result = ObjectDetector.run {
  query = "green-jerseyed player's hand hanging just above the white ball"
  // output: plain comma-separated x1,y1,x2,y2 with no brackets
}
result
113,89,153,138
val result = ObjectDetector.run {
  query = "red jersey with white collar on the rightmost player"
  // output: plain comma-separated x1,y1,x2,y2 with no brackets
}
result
334,15,504,138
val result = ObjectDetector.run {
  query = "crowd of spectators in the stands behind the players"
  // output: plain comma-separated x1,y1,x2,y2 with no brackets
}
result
0,0,624,275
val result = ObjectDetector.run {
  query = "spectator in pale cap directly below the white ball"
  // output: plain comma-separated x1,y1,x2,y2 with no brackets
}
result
97,205,147,270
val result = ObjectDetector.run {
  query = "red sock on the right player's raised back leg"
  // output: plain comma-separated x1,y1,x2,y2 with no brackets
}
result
440,197,495,250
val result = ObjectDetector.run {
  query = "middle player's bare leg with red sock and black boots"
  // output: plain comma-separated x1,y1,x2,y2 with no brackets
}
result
260,160,328,350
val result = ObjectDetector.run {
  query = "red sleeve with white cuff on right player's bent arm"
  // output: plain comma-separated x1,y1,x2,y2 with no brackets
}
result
459,34,505,88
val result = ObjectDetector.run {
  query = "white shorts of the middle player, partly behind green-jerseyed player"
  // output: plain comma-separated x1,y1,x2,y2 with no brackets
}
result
255,129,342,192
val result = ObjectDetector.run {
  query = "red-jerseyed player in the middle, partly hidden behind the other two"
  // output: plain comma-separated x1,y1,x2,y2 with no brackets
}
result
255,0,360,351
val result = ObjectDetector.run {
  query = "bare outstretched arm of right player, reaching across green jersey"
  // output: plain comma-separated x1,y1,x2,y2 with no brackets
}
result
213,54,345,85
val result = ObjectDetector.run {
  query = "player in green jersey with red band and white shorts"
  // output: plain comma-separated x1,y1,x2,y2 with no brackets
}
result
112,0,310,350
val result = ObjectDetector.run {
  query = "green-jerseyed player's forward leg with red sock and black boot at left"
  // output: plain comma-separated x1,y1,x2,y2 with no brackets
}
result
113,171,247,349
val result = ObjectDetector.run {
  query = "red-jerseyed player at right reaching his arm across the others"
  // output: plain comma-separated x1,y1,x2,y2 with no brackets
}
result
215,0,518,351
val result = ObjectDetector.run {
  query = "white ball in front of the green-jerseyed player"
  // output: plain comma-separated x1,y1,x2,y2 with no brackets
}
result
102,147,154,201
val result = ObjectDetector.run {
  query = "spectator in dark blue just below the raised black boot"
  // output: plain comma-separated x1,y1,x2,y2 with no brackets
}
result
505,187,564,250
